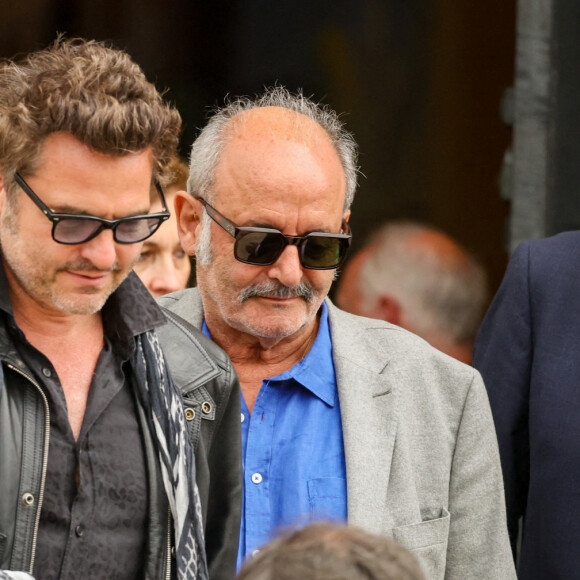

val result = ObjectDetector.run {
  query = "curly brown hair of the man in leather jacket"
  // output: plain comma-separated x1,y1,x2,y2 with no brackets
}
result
0,36,181,196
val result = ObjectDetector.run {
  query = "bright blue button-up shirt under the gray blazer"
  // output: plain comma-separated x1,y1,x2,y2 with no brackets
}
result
204,304,347,566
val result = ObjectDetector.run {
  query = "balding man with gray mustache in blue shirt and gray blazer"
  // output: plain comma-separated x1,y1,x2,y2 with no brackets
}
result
160,87,515,580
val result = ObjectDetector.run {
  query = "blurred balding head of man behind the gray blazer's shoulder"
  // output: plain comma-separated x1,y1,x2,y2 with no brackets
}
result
335,221,488,364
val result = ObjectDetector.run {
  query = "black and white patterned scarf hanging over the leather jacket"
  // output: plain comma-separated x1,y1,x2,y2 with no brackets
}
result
132,331,208,580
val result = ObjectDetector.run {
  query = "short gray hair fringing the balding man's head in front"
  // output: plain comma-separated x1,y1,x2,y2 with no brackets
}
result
187,86,358,212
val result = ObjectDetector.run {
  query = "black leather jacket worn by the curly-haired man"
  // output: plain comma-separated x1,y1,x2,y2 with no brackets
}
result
0,312,242,580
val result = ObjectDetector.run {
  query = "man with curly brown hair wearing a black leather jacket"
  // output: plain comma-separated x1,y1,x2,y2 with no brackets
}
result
0,38,240,579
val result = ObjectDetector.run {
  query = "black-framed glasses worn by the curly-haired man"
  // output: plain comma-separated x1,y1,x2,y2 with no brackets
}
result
14,172,171,245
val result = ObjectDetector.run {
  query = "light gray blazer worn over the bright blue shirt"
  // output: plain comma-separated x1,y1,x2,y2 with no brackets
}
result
160,289,516,580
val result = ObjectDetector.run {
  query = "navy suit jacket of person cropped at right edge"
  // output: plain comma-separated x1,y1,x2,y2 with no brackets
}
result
474,232,580,580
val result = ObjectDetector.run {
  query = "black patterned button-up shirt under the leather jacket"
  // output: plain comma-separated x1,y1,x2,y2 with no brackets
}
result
0,272,168,580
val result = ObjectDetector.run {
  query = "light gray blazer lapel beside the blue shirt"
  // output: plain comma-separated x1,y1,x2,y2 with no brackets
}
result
329,306,398,533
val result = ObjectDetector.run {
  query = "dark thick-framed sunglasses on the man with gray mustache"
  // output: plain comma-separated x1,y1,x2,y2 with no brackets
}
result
194,195,352,270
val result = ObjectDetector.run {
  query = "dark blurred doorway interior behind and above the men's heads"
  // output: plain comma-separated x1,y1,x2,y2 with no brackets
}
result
0,0,516,291
